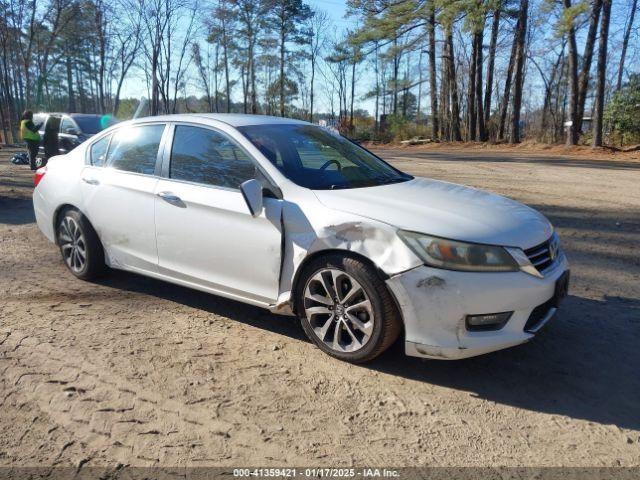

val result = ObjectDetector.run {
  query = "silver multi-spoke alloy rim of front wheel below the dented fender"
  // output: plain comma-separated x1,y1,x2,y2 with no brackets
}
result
304,268,375,353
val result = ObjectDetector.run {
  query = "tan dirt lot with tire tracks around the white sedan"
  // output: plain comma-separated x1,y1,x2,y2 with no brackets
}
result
0,145,640,467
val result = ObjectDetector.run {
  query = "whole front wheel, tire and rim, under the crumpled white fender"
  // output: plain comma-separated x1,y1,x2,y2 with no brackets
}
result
296,254,402,363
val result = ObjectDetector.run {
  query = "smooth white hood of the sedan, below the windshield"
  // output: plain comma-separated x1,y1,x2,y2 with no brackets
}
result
314,177,553,249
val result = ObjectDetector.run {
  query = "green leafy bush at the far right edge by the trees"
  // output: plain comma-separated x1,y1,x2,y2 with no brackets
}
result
604,74,640,144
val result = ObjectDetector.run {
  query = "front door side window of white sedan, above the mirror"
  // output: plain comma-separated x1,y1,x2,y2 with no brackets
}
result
169,125,255,188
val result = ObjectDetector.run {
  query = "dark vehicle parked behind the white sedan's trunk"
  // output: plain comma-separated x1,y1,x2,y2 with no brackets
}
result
33,112,117,158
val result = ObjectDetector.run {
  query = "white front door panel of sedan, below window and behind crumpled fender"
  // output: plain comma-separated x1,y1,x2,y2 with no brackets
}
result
155,179,281,304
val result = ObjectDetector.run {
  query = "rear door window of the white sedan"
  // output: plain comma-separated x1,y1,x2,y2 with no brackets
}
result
107,125,164,175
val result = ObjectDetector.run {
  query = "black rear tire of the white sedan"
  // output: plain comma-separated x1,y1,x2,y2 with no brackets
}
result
56,208,106,280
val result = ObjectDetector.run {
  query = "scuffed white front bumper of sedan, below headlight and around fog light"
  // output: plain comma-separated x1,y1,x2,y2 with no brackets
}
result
387,254,568,360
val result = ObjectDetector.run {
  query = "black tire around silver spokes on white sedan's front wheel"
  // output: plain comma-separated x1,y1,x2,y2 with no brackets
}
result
294,253,402,363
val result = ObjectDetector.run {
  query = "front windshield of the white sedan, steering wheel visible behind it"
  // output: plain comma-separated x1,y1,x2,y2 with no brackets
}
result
238,124,413,190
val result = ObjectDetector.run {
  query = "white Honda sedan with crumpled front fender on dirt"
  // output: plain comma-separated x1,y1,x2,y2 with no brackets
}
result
33,114,569,362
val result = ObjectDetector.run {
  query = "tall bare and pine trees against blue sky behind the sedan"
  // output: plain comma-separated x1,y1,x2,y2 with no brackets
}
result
0,0,640,146
